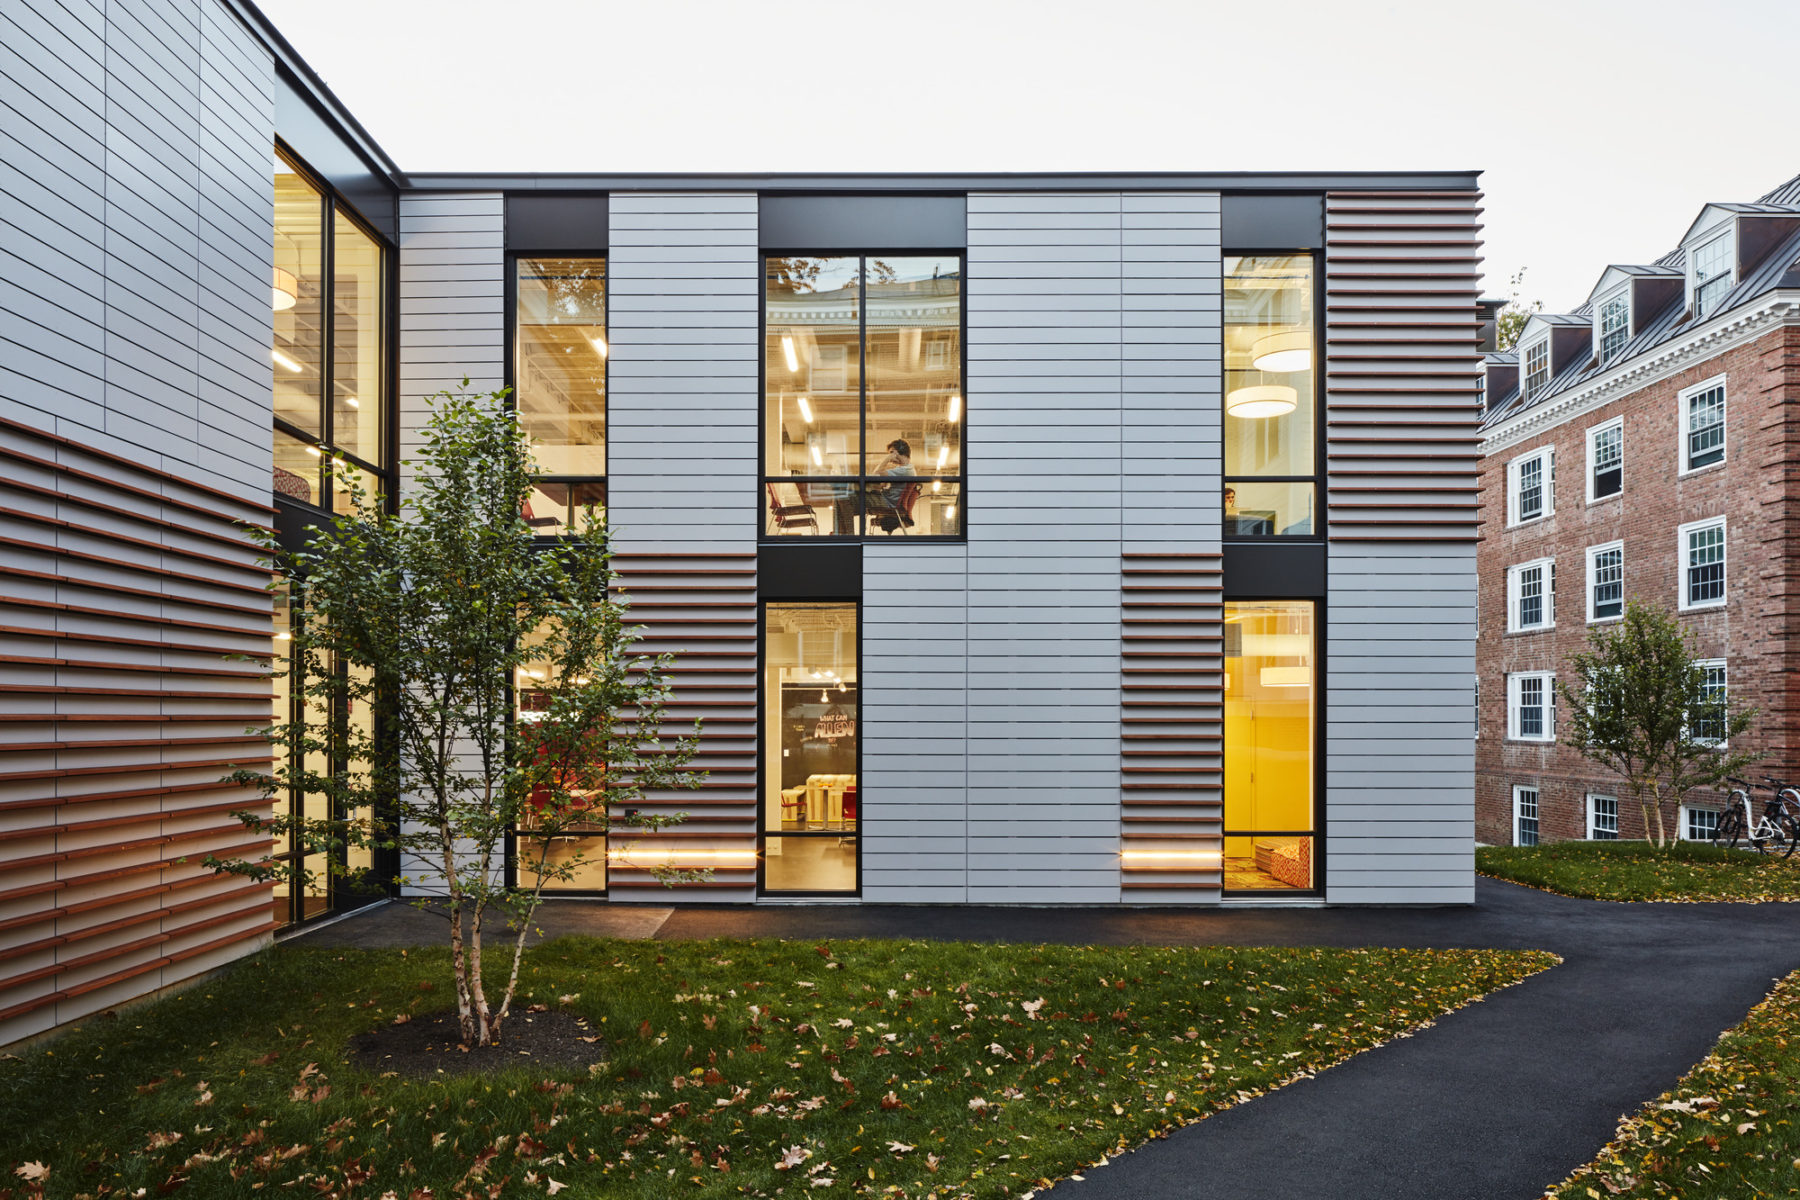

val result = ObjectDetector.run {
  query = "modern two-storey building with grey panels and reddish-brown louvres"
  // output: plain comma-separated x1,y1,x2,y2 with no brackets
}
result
0,0,1480,1040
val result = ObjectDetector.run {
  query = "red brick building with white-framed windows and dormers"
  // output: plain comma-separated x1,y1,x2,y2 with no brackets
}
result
1476,178,1800,846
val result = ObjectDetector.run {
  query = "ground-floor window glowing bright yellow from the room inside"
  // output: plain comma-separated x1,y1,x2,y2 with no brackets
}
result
1224,601,1318,891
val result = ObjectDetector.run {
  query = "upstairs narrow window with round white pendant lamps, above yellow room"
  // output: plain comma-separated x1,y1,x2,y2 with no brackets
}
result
1224,254,1319,538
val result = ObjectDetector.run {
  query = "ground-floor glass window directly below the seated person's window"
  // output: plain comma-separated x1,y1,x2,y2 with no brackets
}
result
761,603,862,892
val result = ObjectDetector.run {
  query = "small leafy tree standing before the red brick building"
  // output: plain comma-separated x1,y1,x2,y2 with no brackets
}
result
1559,599,1759,849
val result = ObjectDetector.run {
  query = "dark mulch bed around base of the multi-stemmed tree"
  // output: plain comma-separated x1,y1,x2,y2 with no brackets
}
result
349,1009,607,1079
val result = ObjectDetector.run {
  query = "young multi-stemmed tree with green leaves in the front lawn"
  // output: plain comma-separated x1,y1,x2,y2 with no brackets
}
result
209,380,706,1045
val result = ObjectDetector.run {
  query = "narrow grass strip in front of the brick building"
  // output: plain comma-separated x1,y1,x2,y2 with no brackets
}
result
1474,842,1800,901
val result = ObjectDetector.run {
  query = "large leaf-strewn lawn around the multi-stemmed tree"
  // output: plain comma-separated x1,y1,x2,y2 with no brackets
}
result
0,939,1557,1200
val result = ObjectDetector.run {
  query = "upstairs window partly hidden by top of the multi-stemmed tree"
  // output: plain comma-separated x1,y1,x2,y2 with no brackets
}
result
513,257,610,534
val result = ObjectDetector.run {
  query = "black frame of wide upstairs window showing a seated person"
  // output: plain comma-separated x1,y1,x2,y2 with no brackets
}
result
756,246,968,543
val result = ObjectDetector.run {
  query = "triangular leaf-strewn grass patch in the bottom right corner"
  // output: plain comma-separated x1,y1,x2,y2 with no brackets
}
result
1550,972,1800,1200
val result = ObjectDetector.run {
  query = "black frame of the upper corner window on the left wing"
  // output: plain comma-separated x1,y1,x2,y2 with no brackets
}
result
270,137,400,515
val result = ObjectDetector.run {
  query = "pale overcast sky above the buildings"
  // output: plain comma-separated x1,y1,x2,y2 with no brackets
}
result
261,0,1800,311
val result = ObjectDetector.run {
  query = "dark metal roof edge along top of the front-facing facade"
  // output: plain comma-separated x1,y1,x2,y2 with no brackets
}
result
387,171,1481,193
